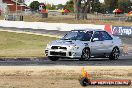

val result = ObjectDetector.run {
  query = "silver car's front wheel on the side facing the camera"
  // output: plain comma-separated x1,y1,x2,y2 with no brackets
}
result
79,48,90,61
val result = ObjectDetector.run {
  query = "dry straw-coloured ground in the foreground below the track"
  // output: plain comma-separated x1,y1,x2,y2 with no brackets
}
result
0,66,132,88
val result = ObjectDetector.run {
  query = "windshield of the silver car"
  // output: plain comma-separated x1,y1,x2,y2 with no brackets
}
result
61,31,92,41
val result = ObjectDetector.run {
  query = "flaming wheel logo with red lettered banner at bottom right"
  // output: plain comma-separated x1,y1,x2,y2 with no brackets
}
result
79,68,131,86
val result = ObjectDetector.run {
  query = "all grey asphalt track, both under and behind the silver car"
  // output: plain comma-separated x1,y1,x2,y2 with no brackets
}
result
0,28,132,66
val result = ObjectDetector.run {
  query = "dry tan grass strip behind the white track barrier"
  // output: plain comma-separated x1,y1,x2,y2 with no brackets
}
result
24,15,132,26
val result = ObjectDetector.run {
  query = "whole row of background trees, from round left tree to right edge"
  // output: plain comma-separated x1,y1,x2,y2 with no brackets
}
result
30,0,132,13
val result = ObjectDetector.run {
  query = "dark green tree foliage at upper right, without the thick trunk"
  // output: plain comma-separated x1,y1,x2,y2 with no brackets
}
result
66,0,132,13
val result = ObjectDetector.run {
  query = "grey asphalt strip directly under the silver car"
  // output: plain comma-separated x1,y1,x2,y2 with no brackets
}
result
0,55,132,66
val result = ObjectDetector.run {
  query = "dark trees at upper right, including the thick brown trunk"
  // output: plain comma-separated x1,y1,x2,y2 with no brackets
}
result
70,0,132,19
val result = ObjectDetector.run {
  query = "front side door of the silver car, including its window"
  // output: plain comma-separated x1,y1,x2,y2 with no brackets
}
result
90,31,104,55
